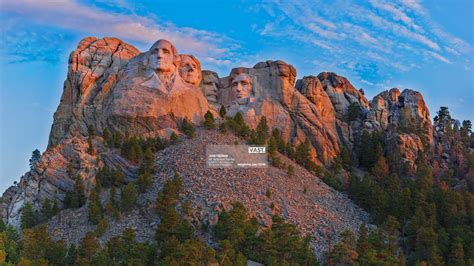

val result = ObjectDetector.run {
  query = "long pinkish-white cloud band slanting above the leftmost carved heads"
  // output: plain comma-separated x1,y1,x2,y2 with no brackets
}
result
0,0,238,69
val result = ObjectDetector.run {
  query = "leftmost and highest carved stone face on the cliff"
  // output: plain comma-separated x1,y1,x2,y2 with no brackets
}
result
150,40,177,73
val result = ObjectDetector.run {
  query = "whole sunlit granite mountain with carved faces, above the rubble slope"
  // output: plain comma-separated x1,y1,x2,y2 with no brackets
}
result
0,37,460,233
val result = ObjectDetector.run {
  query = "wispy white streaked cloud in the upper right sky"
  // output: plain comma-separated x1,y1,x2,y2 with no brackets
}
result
256,0,472,87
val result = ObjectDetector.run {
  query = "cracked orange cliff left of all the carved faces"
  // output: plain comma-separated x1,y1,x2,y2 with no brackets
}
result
49,37,140,146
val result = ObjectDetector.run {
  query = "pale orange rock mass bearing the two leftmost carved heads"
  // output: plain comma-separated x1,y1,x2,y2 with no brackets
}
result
102,40,209,139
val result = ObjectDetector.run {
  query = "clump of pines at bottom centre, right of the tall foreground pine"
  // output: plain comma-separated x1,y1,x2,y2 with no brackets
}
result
214,203,317,265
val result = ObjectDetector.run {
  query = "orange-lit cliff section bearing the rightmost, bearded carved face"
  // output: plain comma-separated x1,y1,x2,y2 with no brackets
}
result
215,61,339,165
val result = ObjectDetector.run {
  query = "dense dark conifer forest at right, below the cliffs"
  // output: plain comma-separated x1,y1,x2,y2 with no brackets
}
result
329,107,474,265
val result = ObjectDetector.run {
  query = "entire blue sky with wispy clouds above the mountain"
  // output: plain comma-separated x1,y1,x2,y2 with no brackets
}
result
0,0,474,191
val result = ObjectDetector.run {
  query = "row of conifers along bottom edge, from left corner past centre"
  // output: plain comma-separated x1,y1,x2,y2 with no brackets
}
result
0,174,318,265
